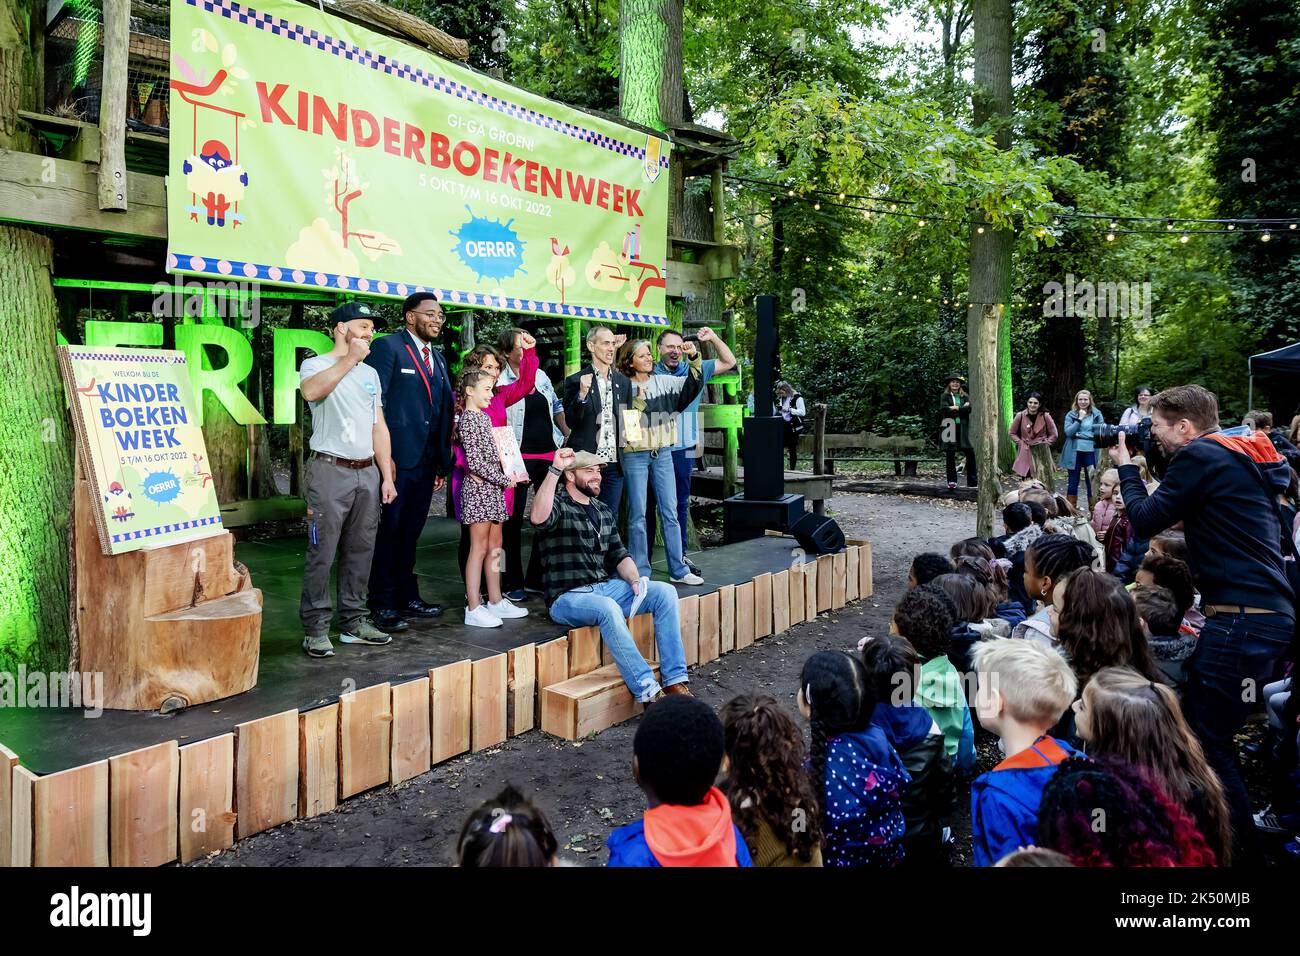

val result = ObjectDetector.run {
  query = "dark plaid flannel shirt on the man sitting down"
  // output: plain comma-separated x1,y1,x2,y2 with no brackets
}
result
533,484,628,607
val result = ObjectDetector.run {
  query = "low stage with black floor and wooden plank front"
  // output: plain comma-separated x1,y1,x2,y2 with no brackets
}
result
0,518,871,865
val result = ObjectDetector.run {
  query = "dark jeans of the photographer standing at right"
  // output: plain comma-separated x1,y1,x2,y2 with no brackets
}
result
1183,613,1295,864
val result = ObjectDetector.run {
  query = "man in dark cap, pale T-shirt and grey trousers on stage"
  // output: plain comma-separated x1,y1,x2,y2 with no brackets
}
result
299,302,397,657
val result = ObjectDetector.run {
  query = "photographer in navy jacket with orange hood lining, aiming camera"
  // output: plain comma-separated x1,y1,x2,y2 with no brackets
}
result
1097,385,1295,862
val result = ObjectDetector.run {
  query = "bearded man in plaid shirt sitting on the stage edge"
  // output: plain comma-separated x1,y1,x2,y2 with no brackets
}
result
529,449,690,704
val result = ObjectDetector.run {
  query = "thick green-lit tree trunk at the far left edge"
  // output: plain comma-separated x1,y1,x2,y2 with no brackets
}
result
0,0,74,671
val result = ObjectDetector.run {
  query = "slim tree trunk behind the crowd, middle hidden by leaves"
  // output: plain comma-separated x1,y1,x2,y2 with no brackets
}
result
966,0,1011,537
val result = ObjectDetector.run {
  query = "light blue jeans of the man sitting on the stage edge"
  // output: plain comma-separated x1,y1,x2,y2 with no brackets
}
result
551,578,686,702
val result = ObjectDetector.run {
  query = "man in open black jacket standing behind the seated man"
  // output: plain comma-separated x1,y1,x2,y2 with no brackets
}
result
564,325,632,515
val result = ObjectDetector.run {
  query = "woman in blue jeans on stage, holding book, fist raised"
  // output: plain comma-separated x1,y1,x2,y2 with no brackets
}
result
619,339,705,585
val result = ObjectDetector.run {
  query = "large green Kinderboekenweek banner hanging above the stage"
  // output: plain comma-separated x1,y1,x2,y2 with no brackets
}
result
168,0,670,325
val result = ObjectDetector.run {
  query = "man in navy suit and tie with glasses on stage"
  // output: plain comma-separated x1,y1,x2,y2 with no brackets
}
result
365,293,454,632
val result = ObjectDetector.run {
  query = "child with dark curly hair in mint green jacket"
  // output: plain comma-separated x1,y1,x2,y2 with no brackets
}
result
894,583,975,773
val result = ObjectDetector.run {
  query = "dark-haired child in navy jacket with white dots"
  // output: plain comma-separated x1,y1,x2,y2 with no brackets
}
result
795,650,911,866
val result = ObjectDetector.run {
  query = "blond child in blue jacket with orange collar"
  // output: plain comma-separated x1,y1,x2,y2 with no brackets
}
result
971,640,1078,866
